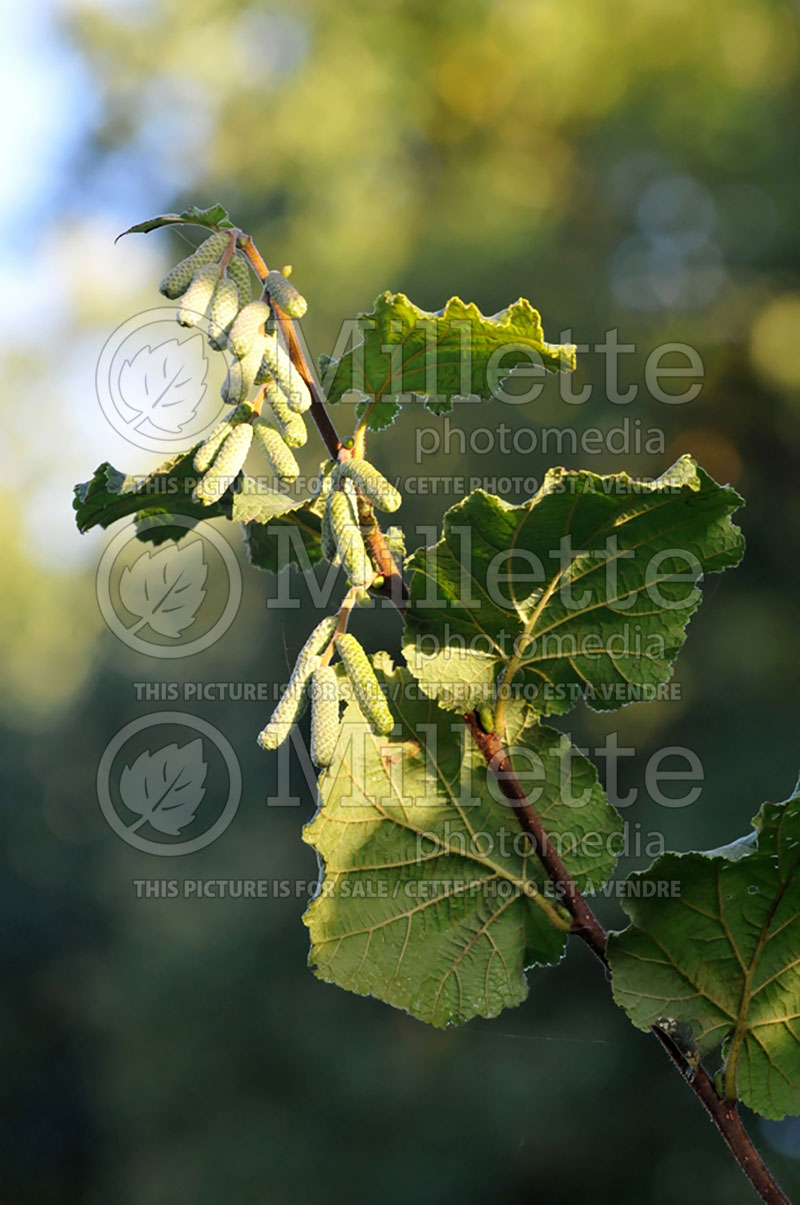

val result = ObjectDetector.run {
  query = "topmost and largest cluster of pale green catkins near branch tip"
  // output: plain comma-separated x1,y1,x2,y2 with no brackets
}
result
159,231,311,506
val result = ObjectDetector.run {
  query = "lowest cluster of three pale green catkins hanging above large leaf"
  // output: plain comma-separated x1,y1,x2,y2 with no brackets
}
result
258,615,394,766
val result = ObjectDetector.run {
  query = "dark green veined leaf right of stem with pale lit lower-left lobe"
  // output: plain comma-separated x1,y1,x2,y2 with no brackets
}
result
404,457,743,715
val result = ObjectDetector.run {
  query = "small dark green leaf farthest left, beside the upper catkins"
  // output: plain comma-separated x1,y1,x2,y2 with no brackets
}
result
72,445,230,543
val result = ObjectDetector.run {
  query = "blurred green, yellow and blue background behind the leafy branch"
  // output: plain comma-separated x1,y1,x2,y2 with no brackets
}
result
0,0,800,1205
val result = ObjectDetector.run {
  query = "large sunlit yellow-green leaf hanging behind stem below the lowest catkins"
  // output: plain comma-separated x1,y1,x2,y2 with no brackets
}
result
304,654,622,1025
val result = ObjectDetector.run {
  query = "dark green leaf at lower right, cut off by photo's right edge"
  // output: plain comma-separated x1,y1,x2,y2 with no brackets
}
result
608,780,800,1118
